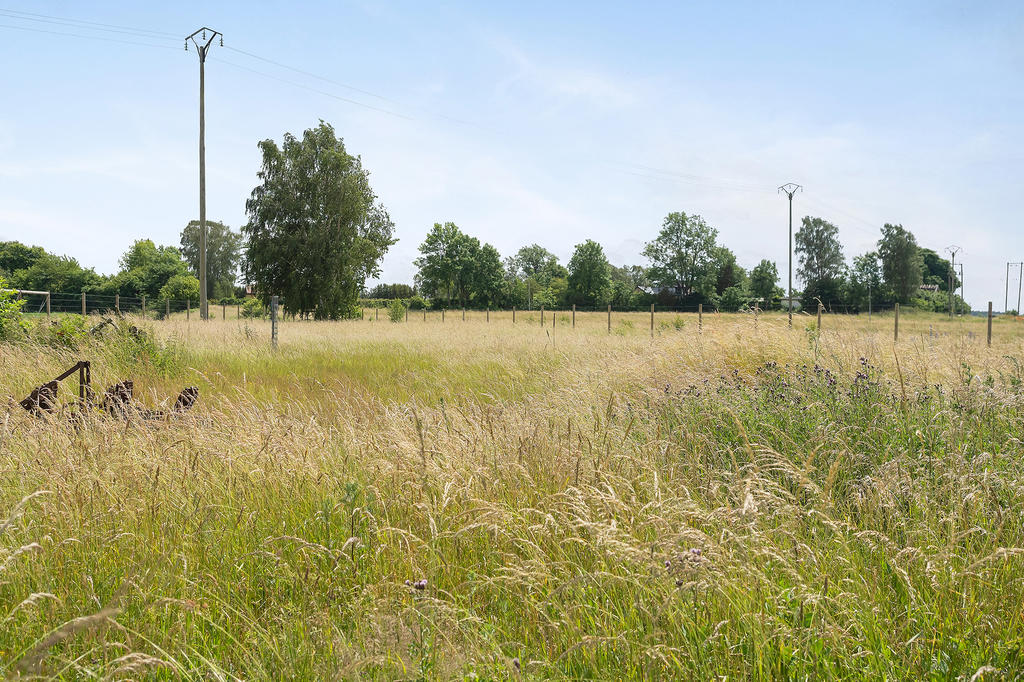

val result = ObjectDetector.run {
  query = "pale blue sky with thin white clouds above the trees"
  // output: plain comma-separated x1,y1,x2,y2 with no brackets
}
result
0,0,1024,310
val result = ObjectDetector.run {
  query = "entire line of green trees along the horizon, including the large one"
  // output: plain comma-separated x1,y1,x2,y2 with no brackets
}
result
0,121,967,319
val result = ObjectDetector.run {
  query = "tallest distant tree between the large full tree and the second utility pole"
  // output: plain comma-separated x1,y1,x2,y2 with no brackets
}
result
643,211,718,296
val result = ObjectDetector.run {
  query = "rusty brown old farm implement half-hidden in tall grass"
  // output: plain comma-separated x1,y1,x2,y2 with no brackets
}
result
22,360,199,420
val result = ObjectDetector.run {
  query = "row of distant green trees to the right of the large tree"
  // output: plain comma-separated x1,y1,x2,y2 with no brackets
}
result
401,212,968,312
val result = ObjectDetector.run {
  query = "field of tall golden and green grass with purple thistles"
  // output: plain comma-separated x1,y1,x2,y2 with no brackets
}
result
0,312,1024,680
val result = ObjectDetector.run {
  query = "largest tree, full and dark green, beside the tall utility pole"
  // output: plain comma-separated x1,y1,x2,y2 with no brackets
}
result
242,121,395,319
